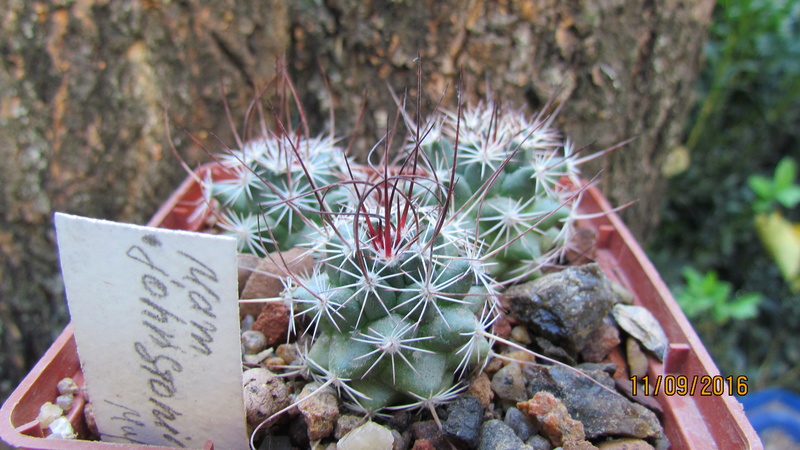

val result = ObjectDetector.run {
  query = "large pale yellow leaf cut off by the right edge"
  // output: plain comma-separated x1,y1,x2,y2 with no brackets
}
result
755,211,800,292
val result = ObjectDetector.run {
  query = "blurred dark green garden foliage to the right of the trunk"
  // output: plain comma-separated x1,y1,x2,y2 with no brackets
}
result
648,0,800,442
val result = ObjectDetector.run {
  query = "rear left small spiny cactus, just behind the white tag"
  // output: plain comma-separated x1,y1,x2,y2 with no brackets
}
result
198,133,345,256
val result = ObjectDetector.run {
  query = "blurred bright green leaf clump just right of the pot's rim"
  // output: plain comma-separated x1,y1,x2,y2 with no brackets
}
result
675,266,761,325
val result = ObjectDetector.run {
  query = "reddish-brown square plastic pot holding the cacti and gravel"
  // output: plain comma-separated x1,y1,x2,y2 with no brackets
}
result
0,165,763,450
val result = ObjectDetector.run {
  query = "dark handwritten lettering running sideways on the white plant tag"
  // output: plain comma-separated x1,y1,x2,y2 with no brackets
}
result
106,235,225,447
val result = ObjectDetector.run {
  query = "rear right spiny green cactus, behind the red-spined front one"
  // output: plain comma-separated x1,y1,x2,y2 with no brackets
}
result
412,102,582,281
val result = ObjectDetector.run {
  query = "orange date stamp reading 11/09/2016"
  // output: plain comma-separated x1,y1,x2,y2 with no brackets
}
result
630,375,749,397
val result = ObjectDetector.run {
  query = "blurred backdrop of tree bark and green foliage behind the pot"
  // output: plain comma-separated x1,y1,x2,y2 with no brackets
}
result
0,0,800,446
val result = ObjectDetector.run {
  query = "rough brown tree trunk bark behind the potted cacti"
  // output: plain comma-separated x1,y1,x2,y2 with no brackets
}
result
0,0,713,398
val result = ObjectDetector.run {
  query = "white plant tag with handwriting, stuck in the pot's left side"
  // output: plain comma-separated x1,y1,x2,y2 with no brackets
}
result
55,213,248,449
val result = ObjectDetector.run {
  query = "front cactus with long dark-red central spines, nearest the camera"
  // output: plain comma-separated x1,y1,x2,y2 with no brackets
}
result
285,153,495,411
